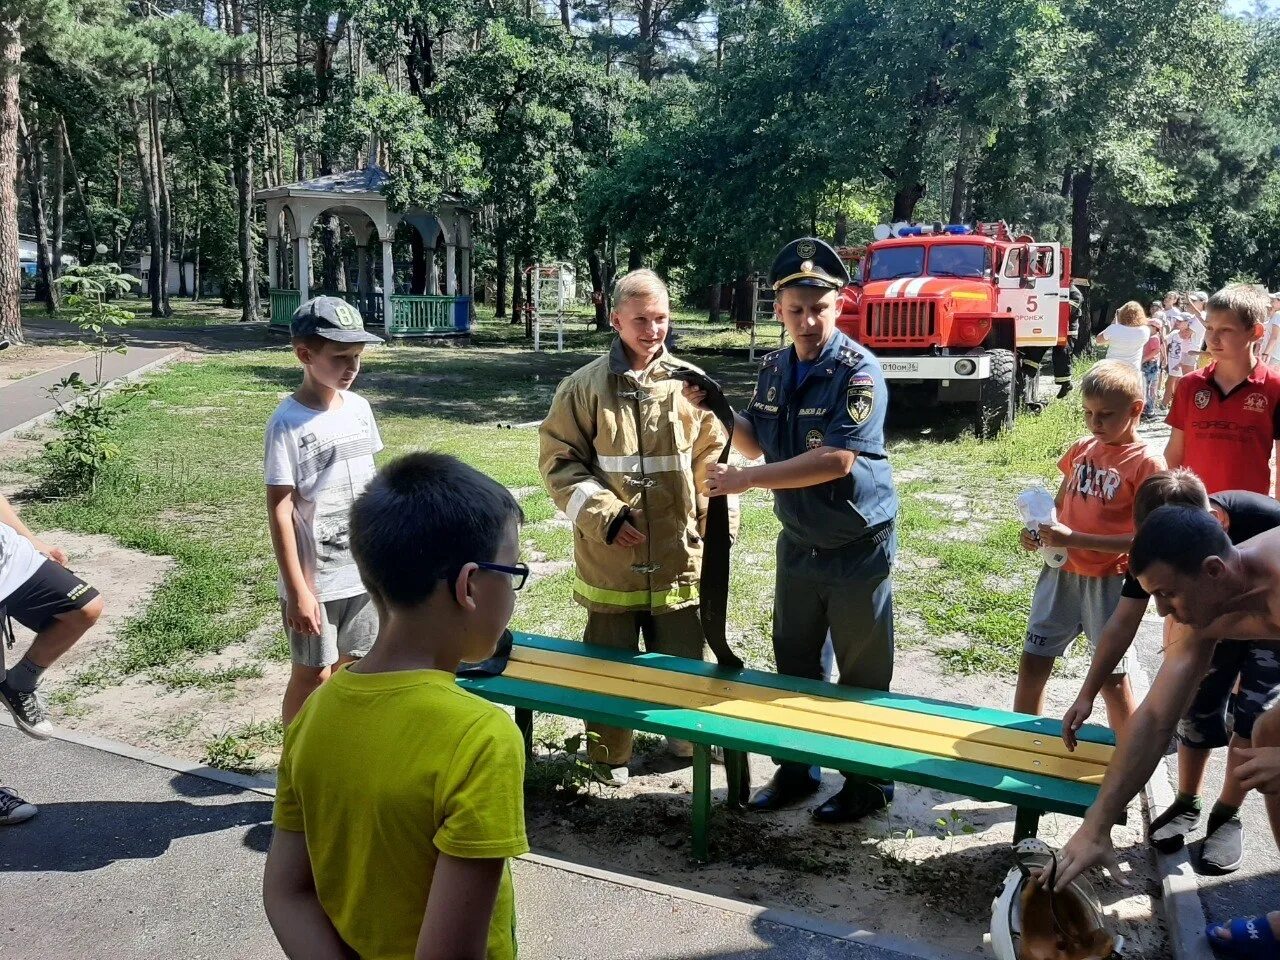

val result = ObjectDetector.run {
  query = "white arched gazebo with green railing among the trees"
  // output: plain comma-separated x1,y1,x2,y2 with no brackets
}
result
255,165,471,337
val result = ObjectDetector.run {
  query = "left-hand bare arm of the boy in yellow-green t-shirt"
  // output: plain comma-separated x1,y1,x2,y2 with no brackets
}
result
262,827,358,960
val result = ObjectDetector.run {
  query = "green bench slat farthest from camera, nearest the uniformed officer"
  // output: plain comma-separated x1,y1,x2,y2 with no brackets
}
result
512,632,1116,746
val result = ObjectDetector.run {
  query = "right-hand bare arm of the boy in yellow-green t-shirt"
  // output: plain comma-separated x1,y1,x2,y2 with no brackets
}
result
413,854,506,960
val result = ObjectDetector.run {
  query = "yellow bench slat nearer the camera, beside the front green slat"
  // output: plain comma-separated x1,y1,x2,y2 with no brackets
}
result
504,659,1105,785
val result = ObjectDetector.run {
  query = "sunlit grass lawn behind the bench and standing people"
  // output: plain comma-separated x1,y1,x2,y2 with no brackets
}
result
10,320,1083,685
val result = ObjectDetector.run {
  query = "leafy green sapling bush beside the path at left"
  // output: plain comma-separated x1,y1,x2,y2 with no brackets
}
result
45,264,143,497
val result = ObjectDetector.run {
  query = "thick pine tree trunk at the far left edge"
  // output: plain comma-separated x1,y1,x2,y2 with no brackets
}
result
0,18,23,343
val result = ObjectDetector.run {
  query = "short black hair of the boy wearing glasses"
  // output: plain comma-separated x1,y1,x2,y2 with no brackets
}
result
351,453,525,607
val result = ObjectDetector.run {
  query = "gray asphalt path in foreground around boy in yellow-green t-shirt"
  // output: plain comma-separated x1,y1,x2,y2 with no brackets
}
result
0,726,931,960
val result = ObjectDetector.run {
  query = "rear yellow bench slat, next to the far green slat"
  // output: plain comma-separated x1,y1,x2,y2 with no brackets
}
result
511,646,1115,769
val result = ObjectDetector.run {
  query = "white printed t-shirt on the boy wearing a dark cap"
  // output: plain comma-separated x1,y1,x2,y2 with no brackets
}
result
265,392,383,602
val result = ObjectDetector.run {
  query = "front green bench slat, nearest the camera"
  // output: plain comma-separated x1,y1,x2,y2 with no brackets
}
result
458,670,1097,817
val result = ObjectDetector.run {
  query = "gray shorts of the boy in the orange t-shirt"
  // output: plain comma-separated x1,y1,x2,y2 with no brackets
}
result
1023,566,1128,673
